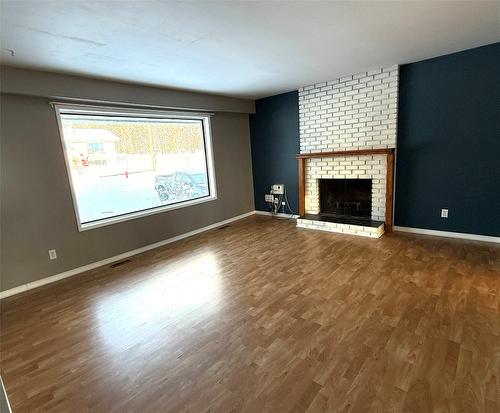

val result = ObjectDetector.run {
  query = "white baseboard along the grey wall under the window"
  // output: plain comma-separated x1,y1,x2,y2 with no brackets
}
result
0,211,256,300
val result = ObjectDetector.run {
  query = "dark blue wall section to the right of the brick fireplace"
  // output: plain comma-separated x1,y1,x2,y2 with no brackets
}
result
395,43,500,236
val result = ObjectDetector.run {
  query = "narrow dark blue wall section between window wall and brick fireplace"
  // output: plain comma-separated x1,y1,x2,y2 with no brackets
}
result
250,91,299,213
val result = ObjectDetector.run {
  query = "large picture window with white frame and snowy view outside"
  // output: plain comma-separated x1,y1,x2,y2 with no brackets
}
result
55,104,216,230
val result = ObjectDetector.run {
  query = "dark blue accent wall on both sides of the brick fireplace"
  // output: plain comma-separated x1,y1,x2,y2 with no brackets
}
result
250,43,500,236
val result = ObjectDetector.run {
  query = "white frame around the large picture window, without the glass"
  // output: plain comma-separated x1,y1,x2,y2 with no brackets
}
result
51,102,217,232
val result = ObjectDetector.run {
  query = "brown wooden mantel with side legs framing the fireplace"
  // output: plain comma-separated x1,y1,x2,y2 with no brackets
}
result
297,148,394,232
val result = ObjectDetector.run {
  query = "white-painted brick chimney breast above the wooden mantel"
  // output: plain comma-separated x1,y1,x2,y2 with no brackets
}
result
299,66,399,153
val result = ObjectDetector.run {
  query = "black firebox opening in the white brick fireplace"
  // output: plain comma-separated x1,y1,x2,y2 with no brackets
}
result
319,179,372,219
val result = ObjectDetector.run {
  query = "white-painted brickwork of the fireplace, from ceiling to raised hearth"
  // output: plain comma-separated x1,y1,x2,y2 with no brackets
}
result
297,66,399,237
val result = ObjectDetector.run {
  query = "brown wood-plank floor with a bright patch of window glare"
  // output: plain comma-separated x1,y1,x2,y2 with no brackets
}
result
1,216,500,413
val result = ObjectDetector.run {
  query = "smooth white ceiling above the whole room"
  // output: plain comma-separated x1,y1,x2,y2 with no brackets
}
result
0,0,500,98
